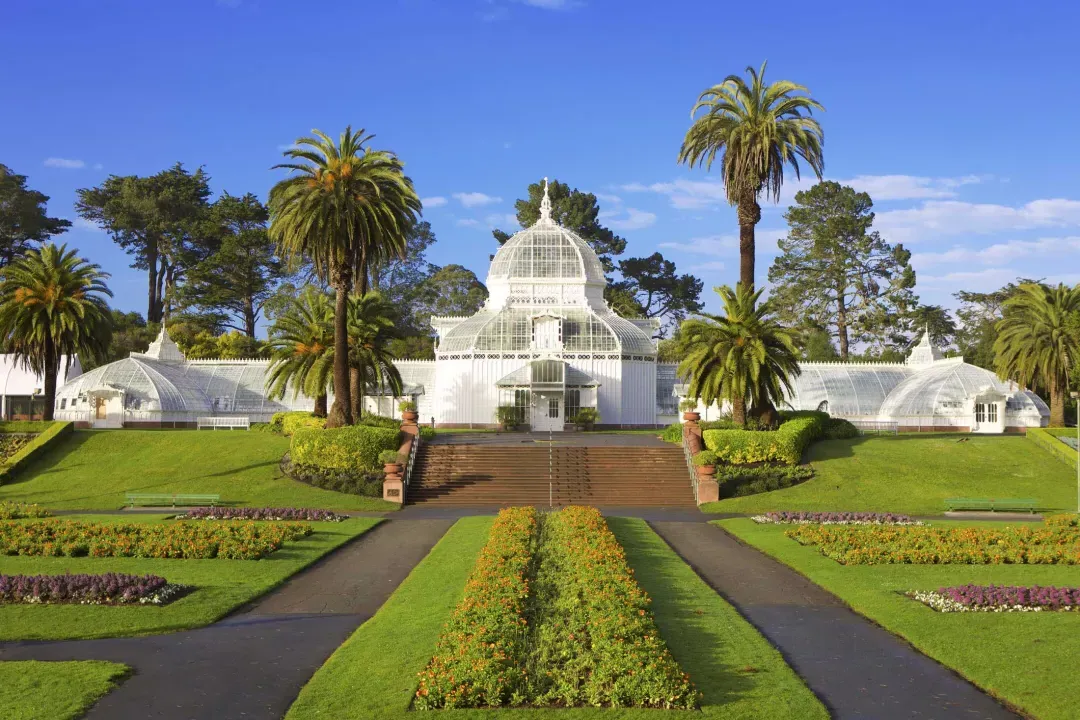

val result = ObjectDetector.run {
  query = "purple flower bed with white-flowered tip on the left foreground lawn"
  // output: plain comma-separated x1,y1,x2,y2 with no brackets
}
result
0,572,189,604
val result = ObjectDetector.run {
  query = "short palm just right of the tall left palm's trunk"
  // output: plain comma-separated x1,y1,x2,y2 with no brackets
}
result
349,293,404,422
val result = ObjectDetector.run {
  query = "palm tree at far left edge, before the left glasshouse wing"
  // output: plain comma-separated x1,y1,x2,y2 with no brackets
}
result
0,243,112,420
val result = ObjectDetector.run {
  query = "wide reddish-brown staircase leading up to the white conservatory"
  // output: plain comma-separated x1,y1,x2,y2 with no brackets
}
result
406,445,694,507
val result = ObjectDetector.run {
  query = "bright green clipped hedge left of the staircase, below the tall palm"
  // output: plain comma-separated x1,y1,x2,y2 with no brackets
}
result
288,425,401,473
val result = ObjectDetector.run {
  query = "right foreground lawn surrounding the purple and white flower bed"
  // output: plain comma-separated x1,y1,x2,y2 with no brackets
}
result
716,518,1080,720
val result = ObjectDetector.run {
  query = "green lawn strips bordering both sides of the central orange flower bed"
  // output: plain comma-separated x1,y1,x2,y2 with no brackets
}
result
287,517,828,720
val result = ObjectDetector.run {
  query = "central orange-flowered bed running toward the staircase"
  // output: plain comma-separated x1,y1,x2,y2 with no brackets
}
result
414,507,701,710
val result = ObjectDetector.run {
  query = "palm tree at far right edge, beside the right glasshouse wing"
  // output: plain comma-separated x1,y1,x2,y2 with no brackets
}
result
994,283,1080,427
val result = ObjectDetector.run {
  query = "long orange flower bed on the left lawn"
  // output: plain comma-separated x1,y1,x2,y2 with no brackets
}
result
0,520,312,560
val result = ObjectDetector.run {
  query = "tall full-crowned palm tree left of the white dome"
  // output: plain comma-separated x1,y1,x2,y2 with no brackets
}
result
269,126,420,427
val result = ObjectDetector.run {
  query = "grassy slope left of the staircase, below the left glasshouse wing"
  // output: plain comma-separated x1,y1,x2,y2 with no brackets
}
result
0,430,397,511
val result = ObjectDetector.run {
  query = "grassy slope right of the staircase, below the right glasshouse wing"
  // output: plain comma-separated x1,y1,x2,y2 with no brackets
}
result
702,435,1076,515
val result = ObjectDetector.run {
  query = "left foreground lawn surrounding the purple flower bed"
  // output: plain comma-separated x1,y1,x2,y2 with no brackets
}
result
0,515,381,639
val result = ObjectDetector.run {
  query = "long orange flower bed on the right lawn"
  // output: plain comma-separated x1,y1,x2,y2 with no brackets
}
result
785,525,1080,565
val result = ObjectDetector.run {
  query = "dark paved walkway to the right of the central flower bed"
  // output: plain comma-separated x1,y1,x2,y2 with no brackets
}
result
652,522,1018,720
